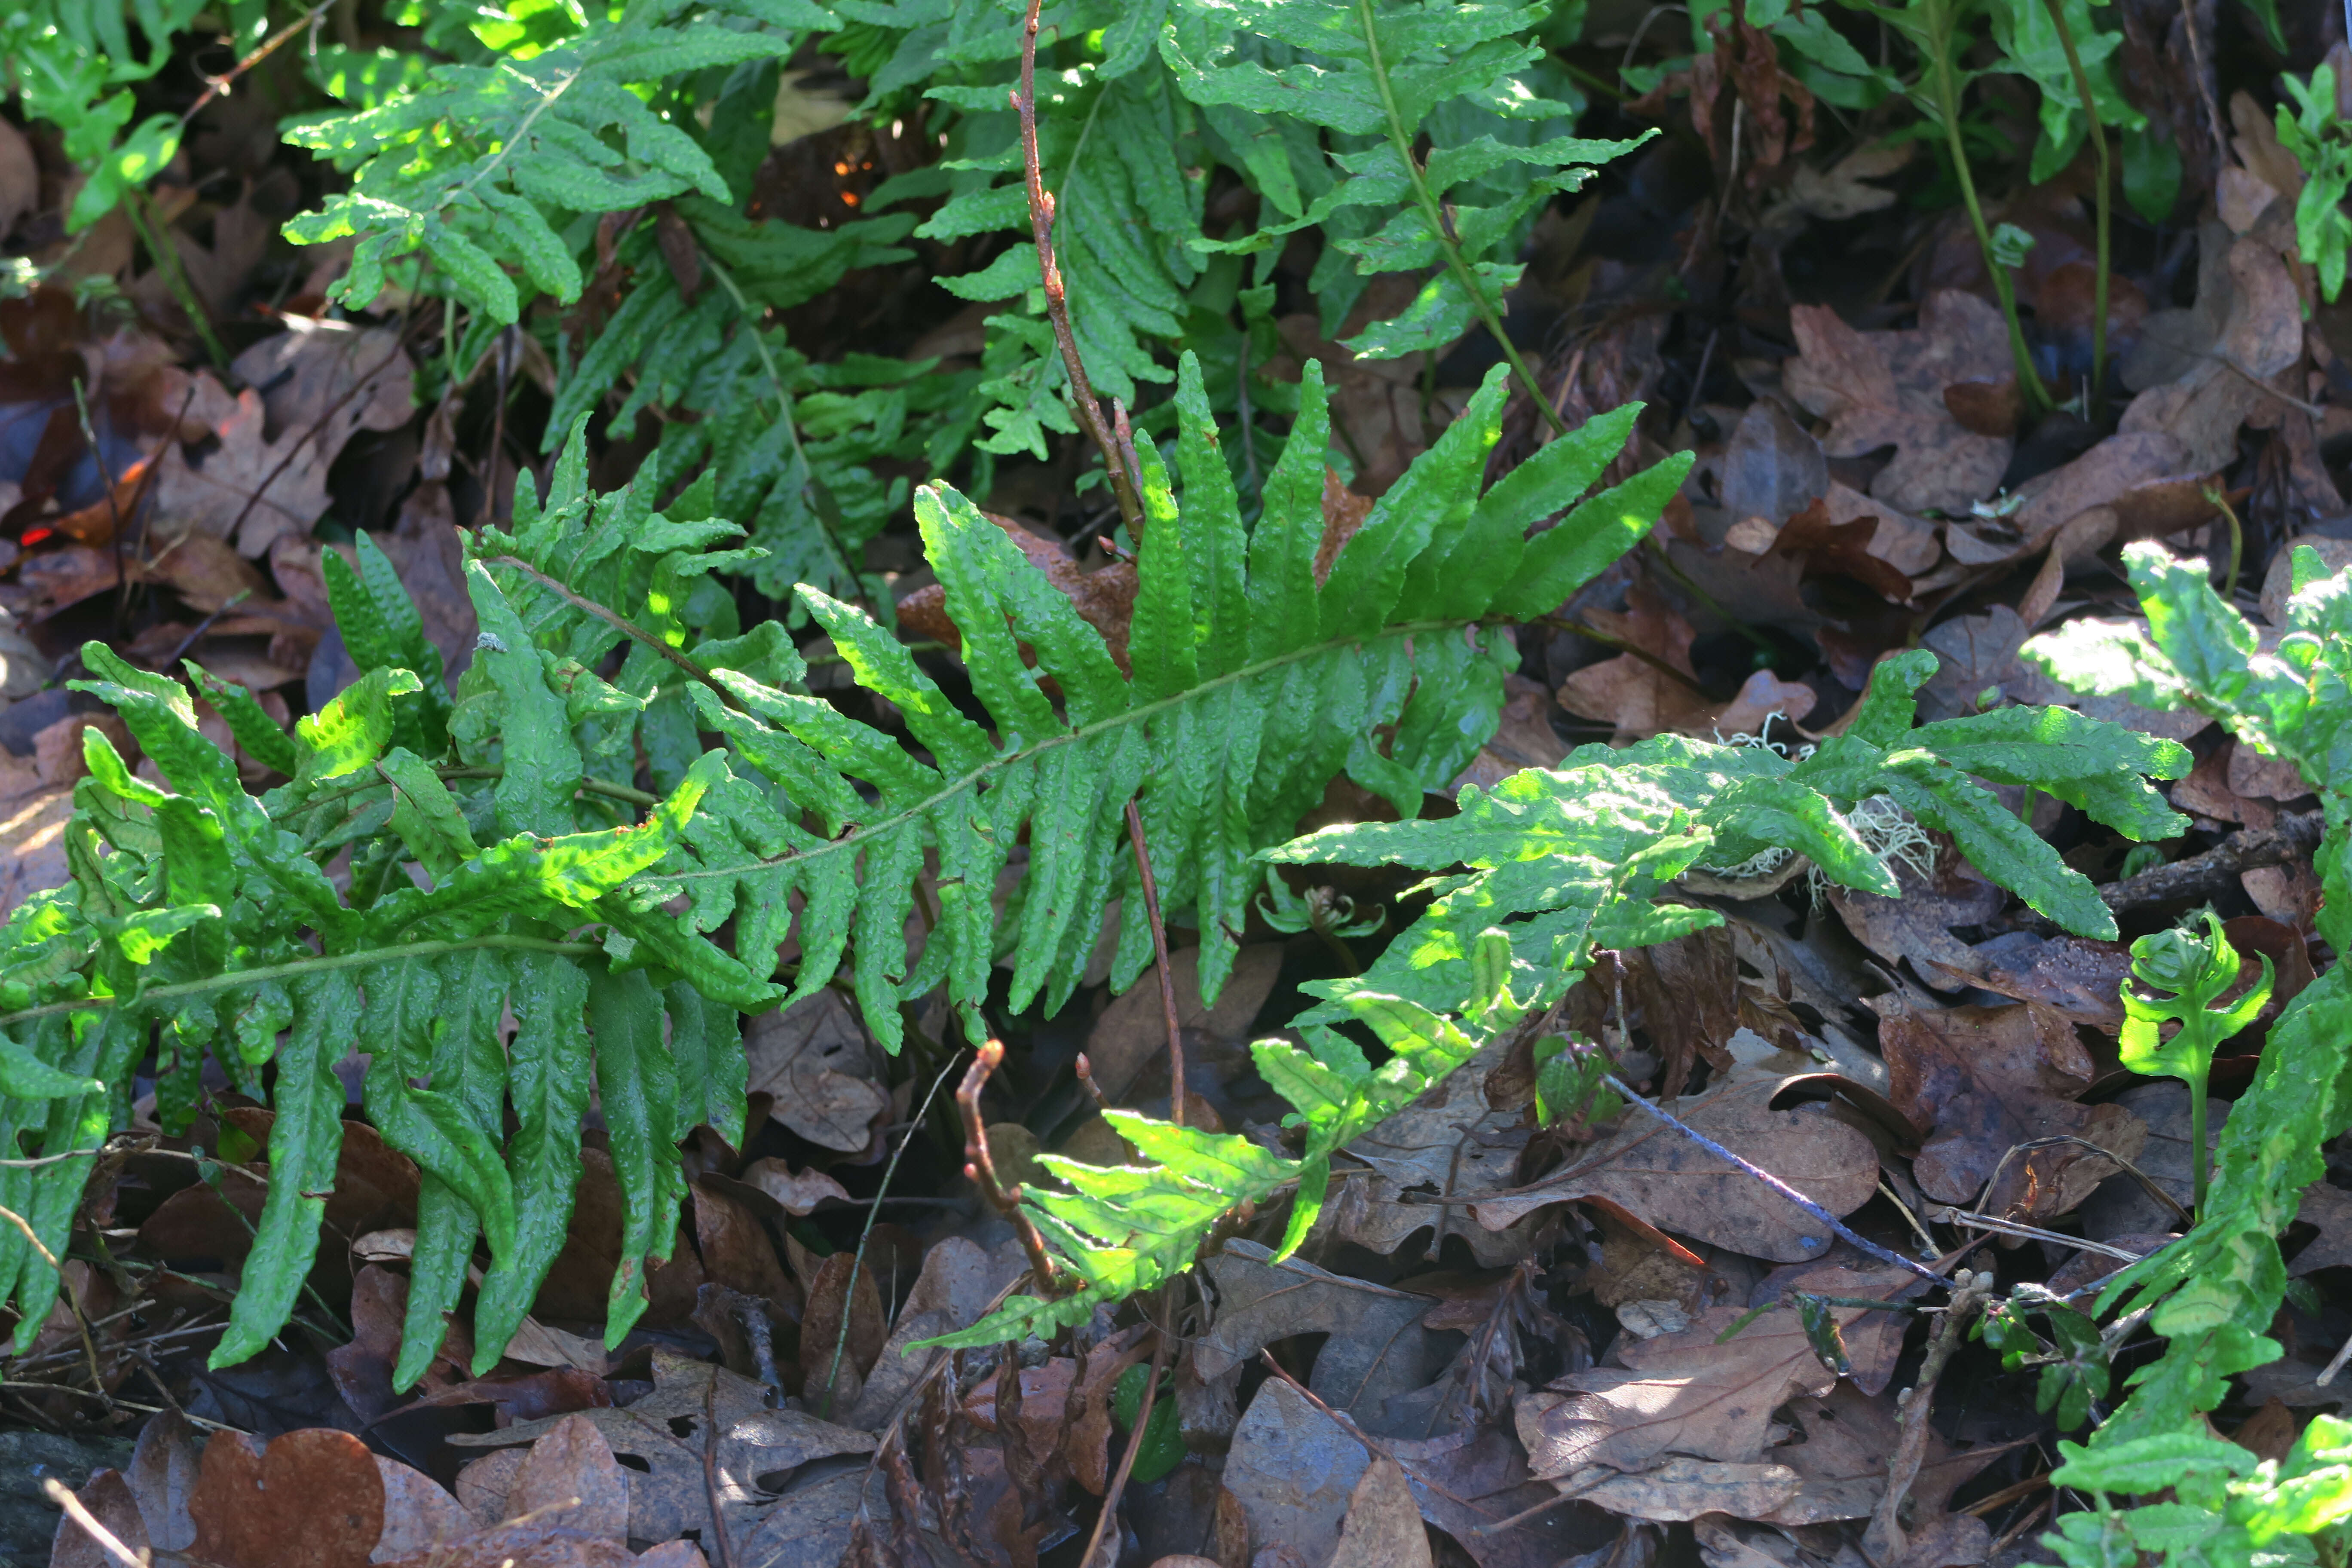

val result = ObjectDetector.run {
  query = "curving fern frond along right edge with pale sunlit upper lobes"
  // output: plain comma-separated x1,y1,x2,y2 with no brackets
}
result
2025,543,2352,1514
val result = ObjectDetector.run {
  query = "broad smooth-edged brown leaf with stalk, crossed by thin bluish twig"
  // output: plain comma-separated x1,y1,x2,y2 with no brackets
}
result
1470,1074,1879,1262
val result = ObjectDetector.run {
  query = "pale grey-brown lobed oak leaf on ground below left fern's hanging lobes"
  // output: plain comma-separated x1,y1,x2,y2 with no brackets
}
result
447,1349,875,1542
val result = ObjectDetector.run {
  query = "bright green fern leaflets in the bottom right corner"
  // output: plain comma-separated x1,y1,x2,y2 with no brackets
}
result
2042,1415,2352,1568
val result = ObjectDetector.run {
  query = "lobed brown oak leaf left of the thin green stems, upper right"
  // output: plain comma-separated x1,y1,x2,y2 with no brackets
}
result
1783,289,2011,512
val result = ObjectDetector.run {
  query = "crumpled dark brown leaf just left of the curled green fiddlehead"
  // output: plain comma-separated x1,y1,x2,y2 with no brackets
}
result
1874,994,2147,1220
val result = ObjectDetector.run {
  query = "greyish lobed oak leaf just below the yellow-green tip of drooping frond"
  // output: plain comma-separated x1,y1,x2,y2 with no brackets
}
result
1192,1241,1444,1422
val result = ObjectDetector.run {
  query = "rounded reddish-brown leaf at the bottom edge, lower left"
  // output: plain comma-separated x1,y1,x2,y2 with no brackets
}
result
188,1427,383,1568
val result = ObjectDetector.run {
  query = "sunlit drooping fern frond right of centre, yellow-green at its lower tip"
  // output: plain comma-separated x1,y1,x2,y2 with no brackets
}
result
943,651,2190,1344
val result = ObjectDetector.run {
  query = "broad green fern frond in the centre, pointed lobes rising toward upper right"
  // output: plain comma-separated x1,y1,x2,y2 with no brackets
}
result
640,357,1689,1048
